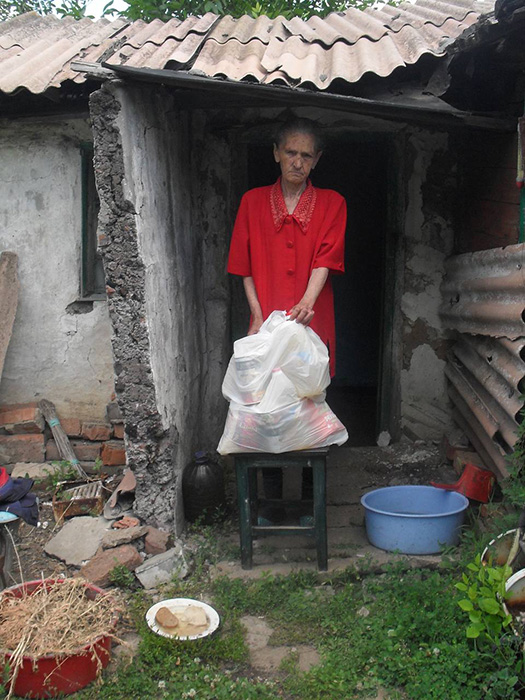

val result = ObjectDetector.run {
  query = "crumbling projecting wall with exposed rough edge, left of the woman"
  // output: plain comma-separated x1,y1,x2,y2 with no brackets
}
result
91,83,229,532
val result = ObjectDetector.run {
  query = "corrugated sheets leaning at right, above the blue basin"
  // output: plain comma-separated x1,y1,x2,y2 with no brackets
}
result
440,244,525,476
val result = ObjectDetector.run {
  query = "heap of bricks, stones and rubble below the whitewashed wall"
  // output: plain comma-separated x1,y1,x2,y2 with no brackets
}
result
0,402,188,589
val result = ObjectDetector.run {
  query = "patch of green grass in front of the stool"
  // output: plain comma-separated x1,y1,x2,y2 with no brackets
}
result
66,567,518,700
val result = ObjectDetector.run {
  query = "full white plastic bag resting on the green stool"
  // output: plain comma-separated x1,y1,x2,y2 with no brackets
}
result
217,311,348,454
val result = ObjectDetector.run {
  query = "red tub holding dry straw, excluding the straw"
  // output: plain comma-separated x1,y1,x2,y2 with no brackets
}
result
2,579,118,698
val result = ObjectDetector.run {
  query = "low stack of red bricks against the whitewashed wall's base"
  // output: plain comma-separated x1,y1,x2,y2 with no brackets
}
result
0,402,126,467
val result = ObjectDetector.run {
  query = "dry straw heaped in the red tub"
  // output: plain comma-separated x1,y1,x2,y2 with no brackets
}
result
0,578,117,697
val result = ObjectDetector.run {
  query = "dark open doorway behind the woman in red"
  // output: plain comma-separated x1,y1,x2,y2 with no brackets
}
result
247,137,388,446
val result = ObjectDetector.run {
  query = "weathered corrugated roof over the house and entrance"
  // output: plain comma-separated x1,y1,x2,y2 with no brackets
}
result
0,0,494,93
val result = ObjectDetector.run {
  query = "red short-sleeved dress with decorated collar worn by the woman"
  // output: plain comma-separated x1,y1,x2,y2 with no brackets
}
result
228,178,346,376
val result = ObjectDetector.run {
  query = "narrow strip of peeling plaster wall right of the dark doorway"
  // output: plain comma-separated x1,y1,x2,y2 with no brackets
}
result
401,131,456,440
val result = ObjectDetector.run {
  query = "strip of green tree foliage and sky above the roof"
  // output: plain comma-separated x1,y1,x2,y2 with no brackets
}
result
0,0,382,22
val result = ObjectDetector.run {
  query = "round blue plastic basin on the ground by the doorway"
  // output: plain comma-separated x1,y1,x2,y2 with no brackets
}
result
361,486,469,554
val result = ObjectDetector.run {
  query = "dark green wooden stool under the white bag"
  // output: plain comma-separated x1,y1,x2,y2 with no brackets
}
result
233,448,328,571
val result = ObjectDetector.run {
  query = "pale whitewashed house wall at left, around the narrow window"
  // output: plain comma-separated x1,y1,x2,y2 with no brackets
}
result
0,118,113,420
